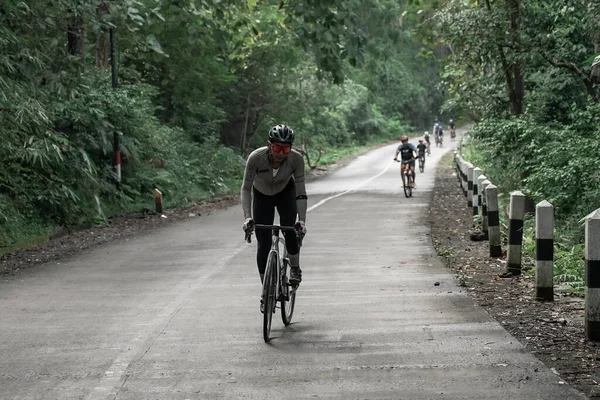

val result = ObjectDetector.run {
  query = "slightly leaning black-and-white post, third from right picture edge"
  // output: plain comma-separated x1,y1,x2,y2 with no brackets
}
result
506,190,525,275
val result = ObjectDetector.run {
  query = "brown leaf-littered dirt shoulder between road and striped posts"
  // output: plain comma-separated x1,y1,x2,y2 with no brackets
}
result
428,153,600,398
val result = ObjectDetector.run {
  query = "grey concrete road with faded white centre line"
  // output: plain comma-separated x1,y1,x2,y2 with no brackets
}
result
0,133,583,400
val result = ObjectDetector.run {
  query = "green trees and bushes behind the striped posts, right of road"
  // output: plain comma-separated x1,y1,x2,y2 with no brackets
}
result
433,0,600,288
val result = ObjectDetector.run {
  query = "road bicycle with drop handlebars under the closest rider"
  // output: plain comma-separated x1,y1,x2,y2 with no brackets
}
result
246,224,303,342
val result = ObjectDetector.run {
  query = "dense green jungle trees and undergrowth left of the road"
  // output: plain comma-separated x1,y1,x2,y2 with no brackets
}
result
0,0,447,247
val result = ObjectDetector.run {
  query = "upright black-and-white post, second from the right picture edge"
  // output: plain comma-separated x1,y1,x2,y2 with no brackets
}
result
535,200,554,301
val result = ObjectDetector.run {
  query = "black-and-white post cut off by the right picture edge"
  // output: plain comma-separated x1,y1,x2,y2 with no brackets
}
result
585,208,600,341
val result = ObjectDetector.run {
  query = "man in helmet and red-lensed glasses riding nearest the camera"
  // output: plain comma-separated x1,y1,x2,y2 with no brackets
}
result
241,125,307,284
